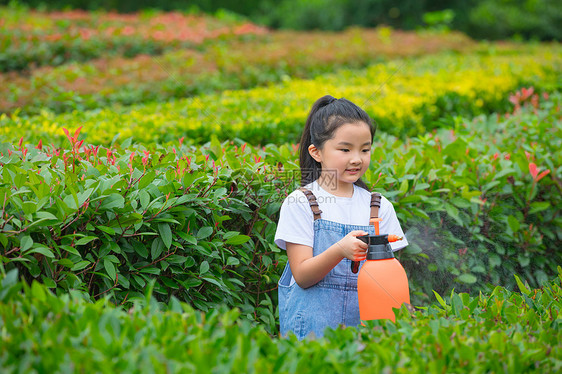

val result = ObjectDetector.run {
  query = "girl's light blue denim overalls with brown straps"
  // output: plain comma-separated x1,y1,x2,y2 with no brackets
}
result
278,188,380,340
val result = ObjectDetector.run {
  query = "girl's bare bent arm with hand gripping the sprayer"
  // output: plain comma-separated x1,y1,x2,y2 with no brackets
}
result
287,230,368,288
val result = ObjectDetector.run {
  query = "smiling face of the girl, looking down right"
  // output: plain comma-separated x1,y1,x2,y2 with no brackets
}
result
309,122,371,191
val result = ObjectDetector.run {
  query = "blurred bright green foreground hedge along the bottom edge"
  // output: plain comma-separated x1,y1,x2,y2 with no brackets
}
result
0,267,562,373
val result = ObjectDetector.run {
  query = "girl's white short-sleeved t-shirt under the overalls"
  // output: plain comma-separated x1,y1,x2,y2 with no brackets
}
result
275,181,408,251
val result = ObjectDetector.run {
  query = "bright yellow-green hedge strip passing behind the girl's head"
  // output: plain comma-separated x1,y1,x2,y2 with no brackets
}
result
0,46,561,145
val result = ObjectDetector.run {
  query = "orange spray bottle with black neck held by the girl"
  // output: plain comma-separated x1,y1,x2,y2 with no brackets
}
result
357,218,410,321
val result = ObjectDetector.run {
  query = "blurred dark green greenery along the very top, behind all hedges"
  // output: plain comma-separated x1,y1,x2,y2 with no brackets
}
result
0,0,562,40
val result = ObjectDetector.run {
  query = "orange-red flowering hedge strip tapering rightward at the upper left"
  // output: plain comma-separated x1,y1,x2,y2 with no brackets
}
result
0,7,266,72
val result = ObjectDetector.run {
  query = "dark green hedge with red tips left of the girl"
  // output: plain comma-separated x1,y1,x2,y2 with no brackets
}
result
0,134,294,326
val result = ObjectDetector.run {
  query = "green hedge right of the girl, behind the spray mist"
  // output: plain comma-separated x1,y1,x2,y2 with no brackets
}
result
376,88,562,300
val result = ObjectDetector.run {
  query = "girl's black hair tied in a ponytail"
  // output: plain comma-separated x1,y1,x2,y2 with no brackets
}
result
299,95,376,190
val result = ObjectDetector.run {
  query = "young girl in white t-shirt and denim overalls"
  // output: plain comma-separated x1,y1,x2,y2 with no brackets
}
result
275,95,408,340
